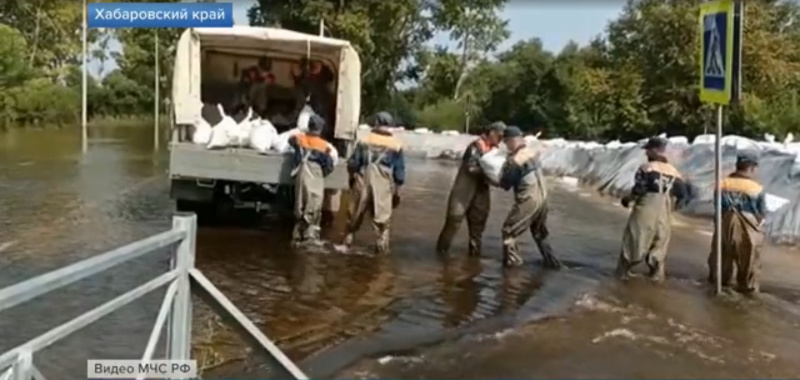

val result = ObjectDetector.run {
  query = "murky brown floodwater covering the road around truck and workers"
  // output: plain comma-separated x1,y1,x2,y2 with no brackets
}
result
0,127,800,379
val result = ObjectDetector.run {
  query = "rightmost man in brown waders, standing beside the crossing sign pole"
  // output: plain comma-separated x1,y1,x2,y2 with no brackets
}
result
708,153,767,293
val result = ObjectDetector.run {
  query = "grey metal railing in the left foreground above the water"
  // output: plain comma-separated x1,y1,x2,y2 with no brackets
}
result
0,214,308,380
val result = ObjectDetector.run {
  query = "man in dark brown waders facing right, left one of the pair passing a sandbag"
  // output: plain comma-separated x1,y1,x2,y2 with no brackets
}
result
436,122,506,256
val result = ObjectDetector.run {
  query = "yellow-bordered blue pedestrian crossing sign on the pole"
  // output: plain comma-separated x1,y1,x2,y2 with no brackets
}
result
700,0,735,105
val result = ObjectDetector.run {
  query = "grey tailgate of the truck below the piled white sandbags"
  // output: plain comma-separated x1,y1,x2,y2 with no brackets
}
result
169,143,348,189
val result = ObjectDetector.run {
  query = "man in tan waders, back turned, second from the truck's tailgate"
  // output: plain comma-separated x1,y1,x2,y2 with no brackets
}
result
344,112,406,253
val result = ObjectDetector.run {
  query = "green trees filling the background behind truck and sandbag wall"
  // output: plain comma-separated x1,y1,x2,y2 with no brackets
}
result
0,0,800,140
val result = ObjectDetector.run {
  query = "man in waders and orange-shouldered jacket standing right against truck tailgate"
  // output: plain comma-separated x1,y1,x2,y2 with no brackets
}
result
289,115,333,244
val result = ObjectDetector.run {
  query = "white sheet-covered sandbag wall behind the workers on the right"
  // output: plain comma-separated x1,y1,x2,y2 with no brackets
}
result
538,142,800,244
